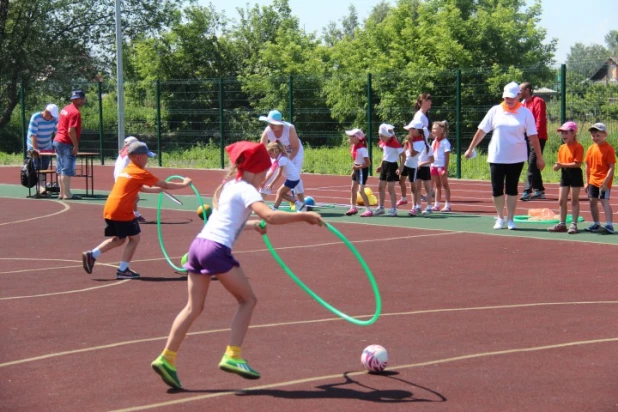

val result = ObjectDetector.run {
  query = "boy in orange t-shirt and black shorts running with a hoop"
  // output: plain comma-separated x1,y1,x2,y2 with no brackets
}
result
82,141,191,279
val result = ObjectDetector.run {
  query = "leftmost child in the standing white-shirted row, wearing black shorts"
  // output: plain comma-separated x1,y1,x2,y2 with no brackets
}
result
345,129,373,217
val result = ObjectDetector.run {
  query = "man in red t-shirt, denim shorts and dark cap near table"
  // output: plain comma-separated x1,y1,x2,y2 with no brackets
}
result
54,90,86,199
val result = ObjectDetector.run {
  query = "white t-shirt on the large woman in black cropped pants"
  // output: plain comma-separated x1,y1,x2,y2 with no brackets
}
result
478,105,537,164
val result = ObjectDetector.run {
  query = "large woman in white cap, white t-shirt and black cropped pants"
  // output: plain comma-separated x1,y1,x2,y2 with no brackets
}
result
465,82,545,230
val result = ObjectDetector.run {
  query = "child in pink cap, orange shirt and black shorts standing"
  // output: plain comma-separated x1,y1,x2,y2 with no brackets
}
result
547,122,584,235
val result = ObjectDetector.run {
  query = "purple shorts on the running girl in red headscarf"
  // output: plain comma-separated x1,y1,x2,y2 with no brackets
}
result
183,237,240,275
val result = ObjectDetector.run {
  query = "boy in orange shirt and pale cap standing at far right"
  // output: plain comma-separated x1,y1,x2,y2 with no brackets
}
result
585,123,616,234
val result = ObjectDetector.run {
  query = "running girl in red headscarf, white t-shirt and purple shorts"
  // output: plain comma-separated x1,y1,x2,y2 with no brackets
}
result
152,142,322,389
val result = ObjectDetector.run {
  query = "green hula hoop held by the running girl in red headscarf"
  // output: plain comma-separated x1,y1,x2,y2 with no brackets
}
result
260,220,382,326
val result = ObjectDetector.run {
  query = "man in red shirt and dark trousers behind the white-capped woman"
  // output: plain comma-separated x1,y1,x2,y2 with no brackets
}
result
519,82,547,201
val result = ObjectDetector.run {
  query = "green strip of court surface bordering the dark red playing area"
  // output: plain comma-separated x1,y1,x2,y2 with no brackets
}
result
0,184,618,245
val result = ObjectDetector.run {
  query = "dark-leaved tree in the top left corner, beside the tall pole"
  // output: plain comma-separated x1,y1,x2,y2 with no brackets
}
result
0,0,181,128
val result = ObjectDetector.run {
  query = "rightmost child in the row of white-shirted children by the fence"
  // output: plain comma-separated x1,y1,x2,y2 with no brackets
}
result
431,120,451,212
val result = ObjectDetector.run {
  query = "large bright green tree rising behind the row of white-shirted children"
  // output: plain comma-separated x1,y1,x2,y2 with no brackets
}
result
325,0,556,124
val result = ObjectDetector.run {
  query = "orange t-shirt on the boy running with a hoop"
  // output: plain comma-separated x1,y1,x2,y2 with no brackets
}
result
103,162,159,222
